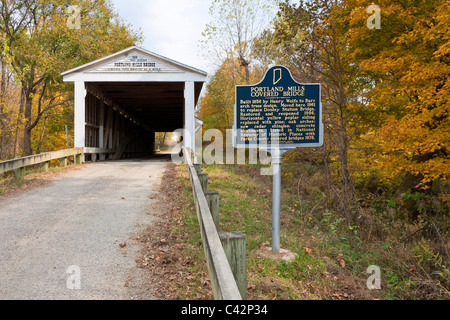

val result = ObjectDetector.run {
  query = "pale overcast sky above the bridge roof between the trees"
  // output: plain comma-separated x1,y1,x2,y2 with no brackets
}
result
112,0,212,72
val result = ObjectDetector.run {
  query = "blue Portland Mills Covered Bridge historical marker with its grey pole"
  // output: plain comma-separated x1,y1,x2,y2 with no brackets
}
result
233,66,323,253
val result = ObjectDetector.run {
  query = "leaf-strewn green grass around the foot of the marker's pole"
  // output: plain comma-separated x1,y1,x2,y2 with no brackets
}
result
173,165,449,300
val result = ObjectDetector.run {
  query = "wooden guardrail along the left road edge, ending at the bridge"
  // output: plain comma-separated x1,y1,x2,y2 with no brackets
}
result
0,148,84,179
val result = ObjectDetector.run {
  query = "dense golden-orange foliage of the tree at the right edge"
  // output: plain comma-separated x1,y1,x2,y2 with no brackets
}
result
338,0,450,191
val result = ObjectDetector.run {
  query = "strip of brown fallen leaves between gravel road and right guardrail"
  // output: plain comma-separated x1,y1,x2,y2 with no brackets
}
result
136,164,212,300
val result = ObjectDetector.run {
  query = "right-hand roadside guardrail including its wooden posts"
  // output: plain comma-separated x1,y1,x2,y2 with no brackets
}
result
183,148,247,300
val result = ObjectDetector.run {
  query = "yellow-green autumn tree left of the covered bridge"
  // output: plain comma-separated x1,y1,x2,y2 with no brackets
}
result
0,0,139,155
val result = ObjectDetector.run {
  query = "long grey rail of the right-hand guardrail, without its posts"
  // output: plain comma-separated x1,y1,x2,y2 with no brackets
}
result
183,148,242,300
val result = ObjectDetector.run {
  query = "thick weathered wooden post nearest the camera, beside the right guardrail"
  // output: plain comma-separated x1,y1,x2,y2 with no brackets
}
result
219,231,247,300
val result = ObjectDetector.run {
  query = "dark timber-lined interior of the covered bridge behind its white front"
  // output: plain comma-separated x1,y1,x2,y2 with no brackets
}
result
85,82,203,161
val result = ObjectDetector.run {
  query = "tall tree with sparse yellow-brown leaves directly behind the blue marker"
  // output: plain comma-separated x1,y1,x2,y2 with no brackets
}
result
258,0,370,219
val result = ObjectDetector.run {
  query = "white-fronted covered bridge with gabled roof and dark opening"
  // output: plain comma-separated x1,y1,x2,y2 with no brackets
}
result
62,47,207,160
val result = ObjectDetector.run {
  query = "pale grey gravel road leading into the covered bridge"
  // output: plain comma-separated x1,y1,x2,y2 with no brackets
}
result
0,157,170,300
